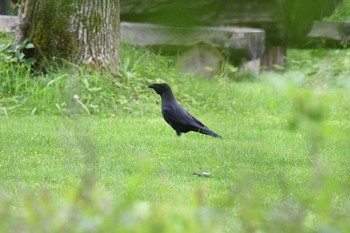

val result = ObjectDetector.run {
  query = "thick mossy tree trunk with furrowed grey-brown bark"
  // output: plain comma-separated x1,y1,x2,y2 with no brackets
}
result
15,0,120,70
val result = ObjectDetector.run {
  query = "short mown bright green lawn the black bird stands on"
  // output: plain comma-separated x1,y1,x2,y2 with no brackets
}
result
0,80,350,232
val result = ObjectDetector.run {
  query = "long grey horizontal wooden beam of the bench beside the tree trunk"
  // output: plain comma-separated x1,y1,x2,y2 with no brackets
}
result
121,22,265,59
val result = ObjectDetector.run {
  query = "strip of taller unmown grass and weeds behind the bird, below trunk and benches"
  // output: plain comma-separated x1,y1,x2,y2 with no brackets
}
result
0,31,350,116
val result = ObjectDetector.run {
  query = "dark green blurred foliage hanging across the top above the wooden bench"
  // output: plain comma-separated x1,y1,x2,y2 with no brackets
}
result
121,0,339,47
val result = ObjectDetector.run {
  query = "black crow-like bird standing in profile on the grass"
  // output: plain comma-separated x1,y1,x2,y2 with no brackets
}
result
148,83,222,138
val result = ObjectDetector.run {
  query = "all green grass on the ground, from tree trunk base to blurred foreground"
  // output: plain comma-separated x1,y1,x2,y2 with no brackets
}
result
0,32,350,232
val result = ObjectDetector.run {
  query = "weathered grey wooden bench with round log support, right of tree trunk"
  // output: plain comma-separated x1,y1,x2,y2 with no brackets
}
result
121,22,265,77
